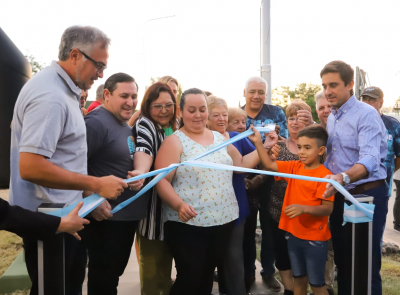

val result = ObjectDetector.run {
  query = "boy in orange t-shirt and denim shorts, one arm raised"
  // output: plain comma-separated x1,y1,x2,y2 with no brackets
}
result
249,125,334,295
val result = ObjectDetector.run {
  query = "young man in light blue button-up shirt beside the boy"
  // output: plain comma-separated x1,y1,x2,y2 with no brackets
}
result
320,61,388,295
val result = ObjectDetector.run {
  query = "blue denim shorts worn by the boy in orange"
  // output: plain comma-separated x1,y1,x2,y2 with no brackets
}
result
286,233,328,287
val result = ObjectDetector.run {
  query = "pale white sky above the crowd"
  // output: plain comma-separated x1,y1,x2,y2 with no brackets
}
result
0,0,400,106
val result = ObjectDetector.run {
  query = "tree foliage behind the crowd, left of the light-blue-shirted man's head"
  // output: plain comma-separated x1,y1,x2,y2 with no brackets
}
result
272,83,321,122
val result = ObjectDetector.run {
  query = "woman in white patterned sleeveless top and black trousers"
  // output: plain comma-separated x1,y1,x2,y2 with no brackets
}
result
155,88,272,295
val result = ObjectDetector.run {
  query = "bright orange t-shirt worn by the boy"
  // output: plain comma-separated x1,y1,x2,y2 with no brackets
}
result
275,161,334,241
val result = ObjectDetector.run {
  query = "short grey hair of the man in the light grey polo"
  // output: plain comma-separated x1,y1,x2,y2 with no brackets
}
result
58,26,111,61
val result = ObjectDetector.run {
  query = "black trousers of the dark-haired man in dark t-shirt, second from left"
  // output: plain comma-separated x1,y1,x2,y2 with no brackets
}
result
82,219,138,295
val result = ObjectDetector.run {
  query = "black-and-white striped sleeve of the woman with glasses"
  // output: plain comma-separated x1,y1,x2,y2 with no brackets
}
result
132,118,157,158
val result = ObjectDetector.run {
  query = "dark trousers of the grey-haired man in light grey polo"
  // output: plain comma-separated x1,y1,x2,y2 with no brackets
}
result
23,234,87,295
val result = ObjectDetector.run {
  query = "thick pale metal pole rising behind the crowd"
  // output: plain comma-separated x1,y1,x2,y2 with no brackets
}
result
260,0,272,104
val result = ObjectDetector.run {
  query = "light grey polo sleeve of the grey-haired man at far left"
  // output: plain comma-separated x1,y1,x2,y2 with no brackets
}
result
19,100,67,158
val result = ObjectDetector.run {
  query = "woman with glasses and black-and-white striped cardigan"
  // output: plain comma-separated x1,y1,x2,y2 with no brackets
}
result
132,82,176,295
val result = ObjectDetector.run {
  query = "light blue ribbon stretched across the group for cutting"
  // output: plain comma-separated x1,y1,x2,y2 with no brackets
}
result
48,126,374,220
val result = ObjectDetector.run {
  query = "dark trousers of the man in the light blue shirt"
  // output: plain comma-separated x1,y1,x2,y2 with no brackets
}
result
330,185,389,295
